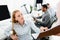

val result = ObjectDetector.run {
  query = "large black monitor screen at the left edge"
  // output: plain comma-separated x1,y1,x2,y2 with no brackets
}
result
0,5,10,21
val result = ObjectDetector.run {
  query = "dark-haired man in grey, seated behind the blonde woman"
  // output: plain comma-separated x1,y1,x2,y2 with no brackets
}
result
35,5,51,31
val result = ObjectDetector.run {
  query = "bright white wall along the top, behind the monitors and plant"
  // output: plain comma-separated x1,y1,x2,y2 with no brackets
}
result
0,0,59,13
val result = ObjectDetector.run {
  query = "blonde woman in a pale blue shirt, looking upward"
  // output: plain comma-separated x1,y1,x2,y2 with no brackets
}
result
5,10,40,40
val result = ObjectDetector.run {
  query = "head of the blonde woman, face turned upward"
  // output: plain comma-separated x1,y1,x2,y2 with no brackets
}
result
13,10,24,25
